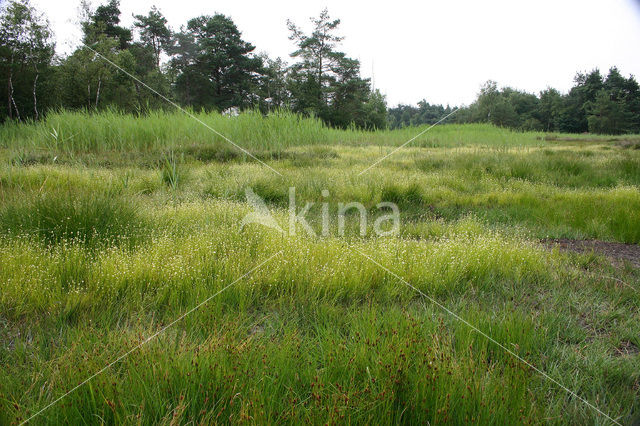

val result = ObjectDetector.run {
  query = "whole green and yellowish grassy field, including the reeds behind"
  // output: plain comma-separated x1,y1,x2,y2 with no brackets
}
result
0,112,640,424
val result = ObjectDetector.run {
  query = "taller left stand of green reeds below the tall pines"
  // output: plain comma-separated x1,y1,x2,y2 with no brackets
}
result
0,110,327,152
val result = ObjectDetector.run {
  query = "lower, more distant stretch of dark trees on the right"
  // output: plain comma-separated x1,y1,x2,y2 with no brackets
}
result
389,67,640,134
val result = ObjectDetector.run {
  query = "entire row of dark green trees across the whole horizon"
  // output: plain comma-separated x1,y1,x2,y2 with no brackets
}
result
0,0,640,134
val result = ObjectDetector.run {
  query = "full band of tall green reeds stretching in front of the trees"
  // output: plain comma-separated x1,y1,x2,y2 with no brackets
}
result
0,110,552,152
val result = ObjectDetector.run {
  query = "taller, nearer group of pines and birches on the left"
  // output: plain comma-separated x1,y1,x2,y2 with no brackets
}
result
0,0,386,128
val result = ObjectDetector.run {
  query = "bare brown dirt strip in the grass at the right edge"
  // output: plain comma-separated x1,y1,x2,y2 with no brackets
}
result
543,238,640,268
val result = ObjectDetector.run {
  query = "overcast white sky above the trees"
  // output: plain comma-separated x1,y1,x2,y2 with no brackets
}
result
32,0,640,105
